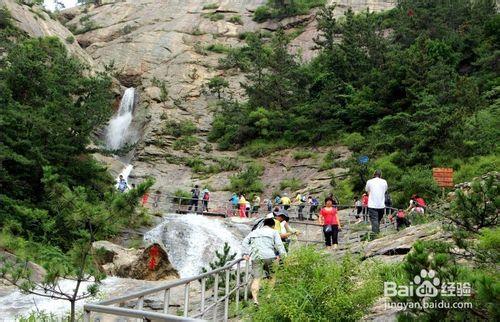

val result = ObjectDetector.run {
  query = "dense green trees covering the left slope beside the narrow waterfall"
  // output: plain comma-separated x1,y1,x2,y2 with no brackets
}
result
0,15,153,320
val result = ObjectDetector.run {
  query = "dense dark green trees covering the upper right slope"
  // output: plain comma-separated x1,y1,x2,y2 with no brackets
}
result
210,0,500,201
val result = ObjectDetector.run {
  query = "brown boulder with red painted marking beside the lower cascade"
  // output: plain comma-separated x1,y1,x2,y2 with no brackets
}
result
92,241,179,281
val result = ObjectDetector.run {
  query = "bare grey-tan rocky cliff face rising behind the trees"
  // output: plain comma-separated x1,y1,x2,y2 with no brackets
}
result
0,0,395,198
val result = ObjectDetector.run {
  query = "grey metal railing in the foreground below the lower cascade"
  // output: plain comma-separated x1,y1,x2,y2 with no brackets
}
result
83,258,249,322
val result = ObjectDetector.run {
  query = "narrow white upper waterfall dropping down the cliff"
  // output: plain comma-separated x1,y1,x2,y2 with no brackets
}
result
106,87,135,150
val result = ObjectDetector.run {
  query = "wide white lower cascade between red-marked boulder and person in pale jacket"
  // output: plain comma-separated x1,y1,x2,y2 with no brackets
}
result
144,214,250,277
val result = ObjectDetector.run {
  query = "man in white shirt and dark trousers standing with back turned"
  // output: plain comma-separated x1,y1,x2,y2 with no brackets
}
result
365,170,387,234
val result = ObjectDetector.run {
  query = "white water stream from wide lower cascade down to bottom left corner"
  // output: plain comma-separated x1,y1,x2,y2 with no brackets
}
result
0,215,250,322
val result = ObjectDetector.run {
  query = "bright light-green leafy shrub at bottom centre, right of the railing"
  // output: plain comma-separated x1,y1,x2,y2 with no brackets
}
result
252,247,382,321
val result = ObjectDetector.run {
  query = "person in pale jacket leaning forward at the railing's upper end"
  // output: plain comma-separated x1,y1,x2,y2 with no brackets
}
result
242,218,286,305
